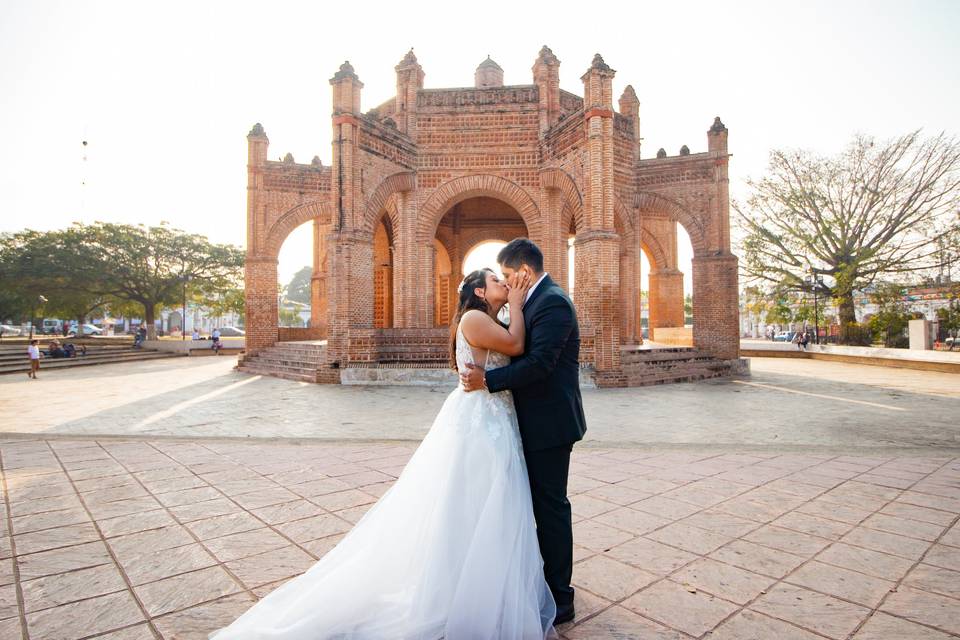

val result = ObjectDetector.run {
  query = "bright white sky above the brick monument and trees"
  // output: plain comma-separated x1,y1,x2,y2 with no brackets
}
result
0,0,960,292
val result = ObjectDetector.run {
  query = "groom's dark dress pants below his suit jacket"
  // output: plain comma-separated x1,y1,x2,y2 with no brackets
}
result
524,444,573,608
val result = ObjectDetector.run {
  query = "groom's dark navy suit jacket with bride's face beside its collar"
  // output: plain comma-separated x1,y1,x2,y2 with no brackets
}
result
486,276,587,451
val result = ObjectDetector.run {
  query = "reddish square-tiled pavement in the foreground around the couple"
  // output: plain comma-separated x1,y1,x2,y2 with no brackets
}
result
0,440,960,640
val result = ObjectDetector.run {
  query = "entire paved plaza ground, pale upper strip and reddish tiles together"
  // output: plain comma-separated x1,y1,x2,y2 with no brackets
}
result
0,358,960,640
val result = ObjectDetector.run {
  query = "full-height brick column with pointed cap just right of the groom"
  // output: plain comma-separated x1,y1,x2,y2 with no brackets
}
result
576,54,621,378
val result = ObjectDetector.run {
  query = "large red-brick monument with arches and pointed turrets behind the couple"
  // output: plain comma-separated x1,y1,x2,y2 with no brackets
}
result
246,47,739,386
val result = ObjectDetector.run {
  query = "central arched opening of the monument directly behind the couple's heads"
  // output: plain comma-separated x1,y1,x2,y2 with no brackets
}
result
433,196,529,327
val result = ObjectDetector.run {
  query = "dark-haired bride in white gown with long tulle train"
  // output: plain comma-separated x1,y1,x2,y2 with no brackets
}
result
211,269,556,640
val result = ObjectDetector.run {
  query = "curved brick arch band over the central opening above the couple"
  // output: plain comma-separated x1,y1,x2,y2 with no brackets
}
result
417,174,540,242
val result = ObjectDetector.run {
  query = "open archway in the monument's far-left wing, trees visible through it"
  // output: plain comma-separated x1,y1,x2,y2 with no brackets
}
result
276,220,315,328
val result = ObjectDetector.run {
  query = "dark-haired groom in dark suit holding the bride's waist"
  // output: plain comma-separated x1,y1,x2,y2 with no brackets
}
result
460,238,587,624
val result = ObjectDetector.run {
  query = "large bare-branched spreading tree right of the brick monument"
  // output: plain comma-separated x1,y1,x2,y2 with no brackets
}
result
733,131,960,325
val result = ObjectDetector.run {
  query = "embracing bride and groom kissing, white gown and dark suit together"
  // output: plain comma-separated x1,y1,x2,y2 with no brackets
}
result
211,238,586,640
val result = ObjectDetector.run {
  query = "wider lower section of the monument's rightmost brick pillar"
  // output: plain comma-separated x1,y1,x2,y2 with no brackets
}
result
693,253,740,359
